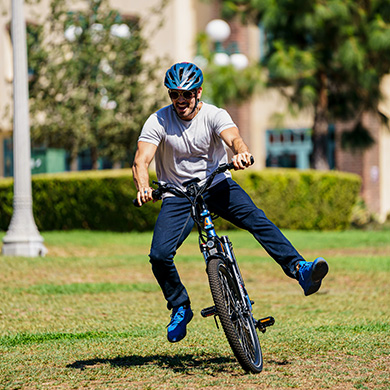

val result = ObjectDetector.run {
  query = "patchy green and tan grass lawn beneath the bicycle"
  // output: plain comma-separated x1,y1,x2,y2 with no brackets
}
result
0,231,390,390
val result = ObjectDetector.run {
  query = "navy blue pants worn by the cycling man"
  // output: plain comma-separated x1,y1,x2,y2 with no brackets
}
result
149,179,303,309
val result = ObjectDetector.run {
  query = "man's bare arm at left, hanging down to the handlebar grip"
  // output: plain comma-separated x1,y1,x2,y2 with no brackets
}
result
133,141,157,206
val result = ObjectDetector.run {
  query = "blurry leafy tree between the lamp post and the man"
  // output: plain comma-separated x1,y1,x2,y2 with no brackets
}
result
28,0,166,170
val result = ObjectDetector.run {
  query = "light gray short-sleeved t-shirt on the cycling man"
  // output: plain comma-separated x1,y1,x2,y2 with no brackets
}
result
138,103,236,191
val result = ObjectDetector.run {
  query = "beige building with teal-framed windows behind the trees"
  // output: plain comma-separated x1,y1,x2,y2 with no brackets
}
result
0,0,390,221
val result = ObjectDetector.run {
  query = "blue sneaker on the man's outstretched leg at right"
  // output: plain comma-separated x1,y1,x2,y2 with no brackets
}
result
298,257,329,296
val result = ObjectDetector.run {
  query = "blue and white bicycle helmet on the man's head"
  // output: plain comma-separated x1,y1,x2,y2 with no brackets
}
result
164,62,203,91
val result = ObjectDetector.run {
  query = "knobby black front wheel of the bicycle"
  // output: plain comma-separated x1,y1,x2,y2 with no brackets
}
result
207,257,263,373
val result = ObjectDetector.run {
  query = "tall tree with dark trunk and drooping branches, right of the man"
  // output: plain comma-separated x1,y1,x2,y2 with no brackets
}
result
222,0,390,169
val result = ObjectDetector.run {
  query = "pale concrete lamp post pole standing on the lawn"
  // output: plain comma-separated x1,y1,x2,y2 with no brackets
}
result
2,0,47,257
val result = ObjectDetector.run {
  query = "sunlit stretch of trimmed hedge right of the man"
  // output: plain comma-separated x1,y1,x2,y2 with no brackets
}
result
235,168,361,230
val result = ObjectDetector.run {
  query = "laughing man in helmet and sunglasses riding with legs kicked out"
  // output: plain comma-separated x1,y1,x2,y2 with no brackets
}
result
133,63,328,342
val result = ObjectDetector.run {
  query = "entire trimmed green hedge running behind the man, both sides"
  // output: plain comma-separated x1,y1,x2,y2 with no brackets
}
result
0,169,361,231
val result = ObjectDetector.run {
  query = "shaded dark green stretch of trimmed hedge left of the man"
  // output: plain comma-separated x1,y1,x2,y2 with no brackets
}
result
0,169,160,231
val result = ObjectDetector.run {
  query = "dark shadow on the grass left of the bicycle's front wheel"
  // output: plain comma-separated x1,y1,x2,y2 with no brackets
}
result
66,354,237,372
